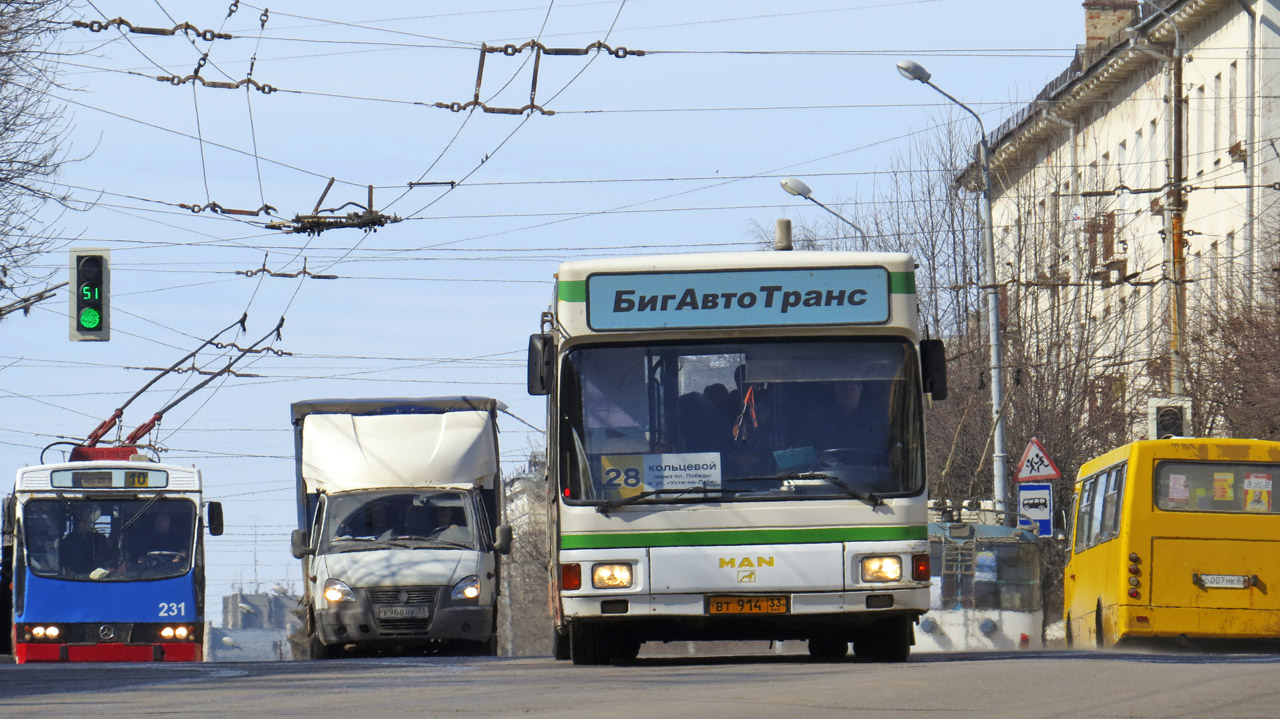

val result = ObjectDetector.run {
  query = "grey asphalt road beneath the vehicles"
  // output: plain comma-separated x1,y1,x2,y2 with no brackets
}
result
0,651,1280,719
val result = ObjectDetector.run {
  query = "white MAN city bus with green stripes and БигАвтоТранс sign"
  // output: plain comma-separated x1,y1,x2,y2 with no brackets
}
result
529,252,946,664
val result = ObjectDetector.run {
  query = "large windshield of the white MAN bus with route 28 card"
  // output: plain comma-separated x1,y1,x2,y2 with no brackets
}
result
559,338,924,507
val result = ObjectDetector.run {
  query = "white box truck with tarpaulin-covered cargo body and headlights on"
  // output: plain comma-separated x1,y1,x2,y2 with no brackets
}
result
292,397,511,659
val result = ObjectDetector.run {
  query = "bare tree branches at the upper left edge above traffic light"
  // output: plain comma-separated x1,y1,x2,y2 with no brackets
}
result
0,0,70,316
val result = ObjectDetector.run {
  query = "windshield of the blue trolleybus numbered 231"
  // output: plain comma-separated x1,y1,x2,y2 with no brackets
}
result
23,498,196,582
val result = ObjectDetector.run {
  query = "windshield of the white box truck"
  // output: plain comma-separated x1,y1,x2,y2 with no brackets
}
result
320,489,476,554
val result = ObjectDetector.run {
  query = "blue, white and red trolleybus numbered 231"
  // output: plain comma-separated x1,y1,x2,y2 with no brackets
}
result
4,448,223,664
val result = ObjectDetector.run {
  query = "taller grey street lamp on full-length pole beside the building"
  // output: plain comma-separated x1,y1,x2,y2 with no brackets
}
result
897,60,1009,521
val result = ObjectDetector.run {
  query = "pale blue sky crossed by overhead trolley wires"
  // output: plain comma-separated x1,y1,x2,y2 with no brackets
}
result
0,0,1084,622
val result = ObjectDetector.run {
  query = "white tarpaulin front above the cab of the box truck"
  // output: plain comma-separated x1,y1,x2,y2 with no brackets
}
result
302,411,498,493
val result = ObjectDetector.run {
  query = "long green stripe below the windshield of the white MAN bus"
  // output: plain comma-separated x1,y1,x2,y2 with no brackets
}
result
561,526,928,549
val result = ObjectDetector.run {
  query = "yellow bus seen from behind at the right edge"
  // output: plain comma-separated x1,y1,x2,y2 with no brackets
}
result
1062,438,1280,647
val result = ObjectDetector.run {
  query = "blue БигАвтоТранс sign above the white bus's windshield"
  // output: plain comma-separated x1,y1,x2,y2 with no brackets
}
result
586,267,890,331
